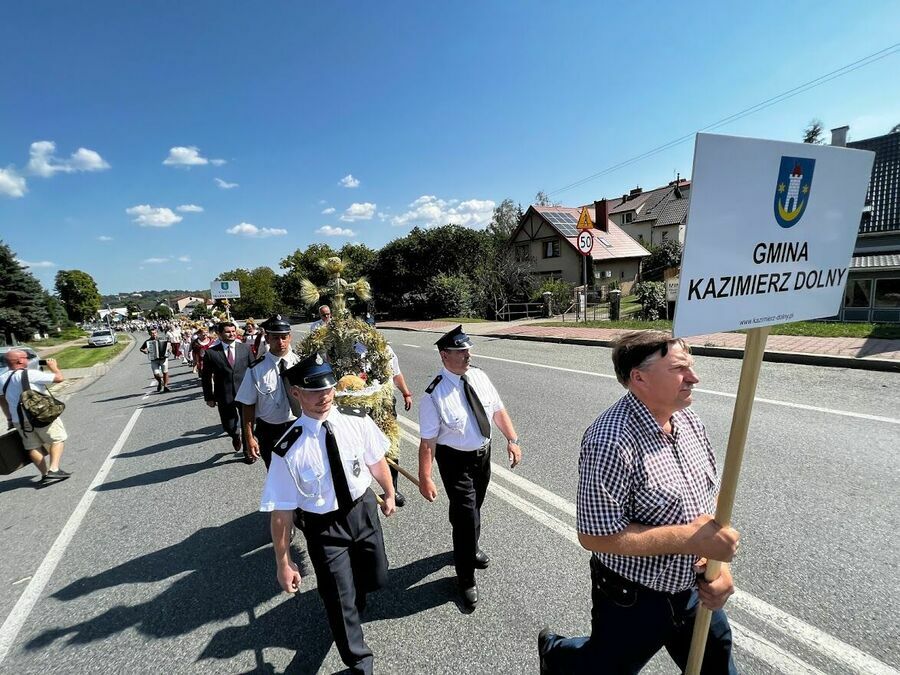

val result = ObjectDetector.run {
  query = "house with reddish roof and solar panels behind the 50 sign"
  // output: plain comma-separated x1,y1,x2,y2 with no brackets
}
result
509,200,650,294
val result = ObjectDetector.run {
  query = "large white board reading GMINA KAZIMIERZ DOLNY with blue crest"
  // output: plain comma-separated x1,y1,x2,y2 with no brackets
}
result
673,134,875,336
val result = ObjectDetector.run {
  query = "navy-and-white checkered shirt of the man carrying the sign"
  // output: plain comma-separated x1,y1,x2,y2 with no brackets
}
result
577,393,719,593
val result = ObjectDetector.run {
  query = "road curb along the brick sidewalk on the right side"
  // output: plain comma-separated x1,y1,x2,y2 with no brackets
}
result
387,326,900,373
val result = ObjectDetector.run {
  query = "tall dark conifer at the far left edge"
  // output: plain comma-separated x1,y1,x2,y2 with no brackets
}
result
0,242,53,344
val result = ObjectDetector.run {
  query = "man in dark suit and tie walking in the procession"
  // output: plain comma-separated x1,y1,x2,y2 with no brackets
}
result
200,321,253,453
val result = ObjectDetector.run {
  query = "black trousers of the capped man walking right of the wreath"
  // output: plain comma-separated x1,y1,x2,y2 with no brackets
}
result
434,444,491,586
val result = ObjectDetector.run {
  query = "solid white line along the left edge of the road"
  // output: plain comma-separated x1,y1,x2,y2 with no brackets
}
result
0,408,143,664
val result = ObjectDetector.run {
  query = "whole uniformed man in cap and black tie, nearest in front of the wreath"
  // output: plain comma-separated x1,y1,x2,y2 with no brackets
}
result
260,354,396,674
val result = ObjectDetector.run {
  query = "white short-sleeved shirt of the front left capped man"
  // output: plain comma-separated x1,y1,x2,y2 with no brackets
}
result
259,406,391,513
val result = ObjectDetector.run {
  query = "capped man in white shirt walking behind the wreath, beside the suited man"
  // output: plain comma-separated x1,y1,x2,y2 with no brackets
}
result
235,314,300,469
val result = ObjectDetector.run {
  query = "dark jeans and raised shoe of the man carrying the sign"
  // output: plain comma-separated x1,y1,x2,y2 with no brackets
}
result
545,557,737,675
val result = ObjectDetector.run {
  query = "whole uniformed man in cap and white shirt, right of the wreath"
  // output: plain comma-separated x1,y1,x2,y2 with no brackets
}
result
419,326,522,611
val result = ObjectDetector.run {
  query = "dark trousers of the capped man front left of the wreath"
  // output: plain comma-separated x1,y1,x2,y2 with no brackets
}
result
303,490,388,675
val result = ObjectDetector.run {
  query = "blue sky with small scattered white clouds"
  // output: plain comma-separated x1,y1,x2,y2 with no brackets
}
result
0,0,900,293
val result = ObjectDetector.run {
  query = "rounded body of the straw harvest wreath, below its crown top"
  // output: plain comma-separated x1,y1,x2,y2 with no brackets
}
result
295,315,400,460
